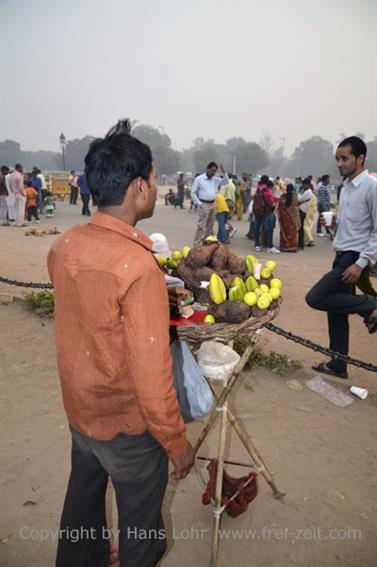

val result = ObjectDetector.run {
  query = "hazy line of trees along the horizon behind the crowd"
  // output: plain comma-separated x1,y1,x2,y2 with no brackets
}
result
0,124,377,177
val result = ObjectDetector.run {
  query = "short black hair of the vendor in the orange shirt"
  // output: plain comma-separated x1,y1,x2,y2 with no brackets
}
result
85,119,153,208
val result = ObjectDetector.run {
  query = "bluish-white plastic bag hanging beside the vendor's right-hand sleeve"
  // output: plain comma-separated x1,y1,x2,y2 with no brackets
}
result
170,340,214,423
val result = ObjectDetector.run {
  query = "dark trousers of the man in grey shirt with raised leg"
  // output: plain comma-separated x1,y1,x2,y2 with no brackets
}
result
306,251,377,373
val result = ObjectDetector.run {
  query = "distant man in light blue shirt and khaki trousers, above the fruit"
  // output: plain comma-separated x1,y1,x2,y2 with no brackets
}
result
191,161,229,246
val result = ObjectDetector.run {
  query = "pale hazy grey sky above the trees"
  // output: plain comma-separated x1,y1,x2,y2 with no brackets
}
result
0,0,377,153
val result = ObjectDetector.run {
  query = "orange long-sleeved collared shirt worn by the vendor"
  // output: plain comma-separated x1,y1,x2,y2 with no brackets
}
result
47,212,187,457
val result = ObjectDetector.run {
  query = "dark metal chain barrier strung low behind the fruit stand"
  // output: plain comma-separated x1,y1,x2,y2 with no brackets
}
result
0,276,377,372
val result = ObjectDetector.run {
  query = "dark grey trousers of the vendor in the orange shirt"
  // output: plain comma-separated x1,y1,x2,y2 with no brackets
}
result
56,428,168,567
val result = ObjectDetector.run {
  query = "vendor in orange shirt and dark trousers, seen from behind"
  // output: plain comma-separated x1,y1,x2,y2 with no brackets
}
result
48,121,194,567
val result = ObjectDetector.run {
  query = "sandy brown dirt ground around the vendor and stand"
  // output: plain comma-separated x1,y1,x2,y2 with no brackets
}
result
0,197,377,567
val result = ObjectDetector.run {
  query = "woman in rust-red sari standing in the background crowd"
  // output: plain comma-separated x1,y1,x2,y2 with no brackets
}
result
277,183,300,252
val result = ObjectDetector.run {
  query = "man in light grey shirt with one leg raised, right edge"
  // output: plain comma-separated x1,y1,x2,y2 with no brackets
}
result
306,136,377,378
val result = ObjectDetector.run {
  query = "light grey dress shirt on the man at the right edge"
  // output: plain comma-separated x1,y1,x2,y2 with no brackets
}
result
333,169,377,269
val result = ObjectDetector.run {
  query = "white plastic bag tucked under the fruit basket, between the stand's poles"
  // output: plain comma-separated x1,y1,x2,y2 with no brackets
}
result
198,341,240,384
